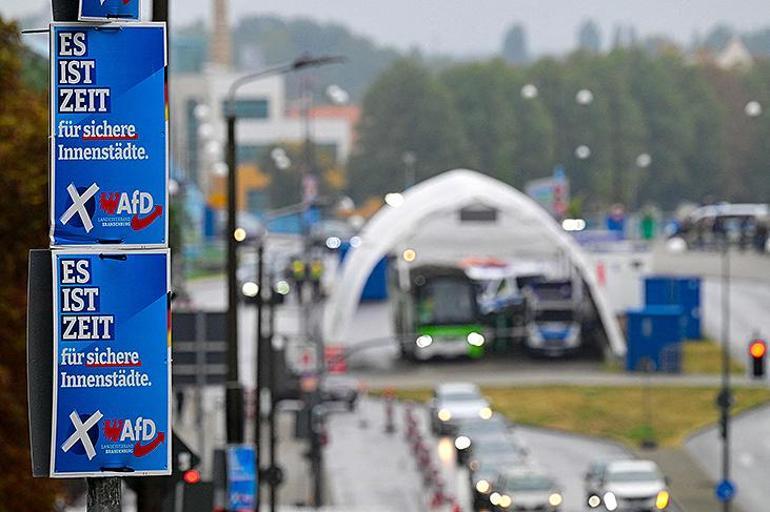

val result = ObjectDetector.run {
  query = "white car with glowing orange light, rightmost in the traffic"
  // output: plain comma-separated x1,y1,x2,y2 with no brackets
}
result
589,460,671,512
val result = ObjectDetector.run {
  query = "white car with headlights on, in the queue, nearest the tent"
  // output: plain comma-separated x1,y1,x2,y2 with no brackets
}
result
429,382,492,435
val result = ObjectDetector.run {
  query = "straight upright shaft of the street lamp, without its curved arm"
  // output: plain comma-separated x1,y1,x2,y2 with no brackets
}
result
225,108,243,444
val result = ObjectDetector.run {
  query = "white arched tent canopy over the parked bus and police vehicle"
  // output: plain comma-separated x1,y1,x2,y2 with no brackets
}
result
323,169,626,357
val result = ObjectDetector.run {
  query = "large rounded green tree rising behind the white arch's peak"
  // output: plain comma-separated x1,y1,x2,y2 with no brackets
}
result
348,59,473,198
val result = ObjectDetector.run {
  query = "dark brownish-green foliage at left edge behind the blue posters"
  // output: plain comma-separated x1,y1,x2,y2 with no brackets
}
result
0,18,55,512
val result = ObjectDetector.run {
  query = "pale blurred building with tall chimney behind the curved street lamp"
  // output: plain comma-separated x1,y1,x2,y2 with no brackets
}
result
170,0,360,212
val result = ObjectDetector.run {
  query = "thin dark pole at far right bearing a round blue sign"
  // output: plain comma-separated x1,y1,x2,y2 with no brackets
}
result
719,240,732,512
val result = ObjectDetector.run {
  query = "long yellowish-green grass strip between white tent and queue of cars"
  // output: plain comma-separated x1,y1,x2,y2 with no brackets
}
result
388,386,770,447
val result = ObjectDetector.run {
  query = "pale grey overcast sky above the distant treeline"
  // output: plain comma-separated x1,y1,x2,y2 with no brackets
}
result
0,0,770,55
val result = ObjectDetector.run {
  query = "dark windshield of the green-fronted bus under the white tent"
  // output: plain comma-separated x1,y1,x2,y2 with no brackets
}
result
417,279,476,325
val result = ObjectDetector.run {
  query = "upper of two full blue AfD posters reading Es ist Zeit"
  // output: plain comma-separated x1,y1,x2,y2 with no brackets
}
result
50,23,168,248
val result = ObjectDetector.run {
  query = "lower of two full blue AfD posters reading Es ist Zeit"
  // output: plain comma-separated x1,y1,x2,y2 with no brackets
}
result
51,249,171,477
